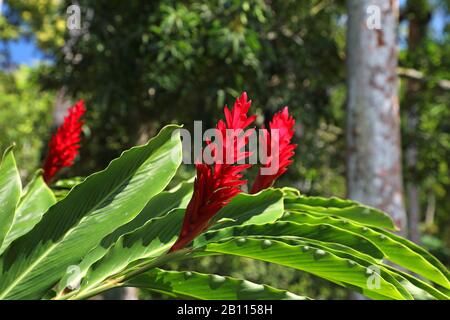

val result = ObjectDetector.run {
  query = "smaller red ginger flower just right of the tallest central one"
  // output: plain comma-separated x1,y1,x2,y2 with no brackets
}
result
250,107,297,194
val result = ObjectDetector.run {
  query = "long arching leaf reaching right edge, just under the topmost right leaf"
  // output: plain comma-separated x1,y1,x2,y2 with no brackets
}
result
282,212,450,288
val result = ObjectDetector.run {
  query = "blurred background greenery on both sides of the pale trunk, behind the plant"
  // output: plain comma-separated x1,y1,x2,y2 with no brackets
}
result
0,0,450,299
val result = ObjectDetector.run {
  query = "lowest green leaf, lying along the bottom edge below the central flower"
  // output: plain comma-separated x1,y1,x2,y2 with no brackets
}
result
123,268,308,300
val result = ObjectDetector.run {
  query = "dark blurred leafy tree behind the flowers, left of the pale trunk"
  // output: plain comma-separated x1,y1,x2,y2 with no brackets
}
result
32,0,344,192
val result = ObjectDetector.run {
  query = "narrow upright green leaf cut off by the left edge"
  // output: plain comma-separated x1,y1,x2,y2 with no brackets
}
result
0,146,22,246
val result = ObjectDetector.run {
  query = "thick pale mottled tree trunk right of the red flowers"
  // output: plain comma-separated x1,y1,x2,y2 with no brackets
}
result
346,0,406,233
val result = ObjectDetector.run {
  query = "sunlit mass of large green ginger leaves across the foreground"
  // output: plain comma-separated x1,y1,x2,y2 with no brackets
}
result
0,129,450,300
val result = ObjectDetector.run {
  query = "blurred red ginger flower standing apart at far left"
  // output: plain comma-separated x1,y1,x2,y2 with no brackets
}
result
43,100,86,183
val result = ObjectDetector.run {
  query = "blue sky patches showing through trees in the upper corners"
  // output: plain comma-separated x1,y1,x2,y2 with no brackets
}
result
3,0,450,65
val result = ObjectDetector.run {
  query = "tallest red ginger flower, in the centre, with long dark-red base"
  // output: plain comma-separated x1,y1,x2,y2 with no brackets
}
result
170,92,256,251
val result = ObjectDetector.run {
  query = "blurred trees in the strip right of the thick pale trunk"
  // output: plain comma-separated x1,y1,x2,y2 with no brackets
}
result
400,0,450,254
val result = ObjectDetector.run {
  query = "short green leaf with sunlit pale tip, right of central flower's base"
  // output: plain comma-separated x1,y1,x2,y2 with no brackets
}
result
210,189,284,230
